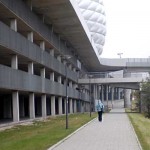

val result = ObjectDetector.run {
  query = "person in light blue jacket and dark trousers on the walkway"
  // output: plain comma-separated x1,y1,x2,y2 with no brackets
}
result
96,100,104,122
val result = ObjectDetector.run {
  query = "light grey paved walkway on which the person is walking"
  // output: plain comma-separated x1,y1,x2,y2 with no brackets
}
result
49,99,141,150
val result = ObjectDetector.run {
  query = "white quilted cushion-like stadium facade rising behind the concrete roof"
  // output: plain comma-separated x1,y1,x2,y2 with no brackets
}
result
76,0,106,54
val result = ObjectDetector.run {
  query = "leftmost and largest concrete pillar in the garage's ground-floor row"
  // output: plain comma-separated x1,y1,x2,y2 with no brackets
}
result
12,91,19,122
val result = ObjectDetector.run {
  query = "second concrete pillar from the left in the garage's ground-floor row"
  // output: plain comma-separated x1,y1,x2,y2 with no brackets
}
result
29,93,35,119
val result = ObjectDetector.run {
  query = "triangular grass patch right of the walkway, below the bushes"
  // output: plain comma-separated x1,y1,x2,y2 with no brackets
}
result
127,110,150,150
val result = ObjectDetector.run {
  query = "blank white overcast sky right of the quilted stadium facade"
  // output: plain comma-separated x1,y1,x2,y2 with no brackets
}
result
101,0,150,58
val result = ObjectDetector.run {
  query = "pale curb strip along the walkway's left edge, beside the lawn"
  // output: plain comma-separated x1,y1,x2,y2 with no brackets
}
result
47,117,97,150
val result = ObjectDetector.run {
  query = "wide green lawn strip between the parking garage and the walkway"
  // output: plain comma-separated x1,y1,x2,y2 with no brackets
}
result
0,113,97,150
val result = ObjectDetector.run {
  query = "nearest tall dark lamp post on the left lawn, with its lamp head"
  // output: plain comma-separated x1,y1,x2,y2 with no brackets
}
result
63,55,71,129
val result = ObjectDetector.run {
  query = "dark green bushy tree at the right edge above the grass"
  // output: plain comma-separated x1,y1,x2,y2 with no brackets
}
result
141,78,150,118
